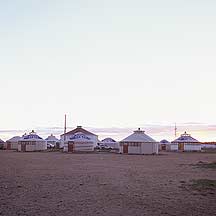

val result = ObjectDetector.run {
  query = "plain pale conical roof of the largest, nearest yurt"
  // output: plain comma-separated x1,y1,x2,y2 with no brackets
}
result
121,128,156,142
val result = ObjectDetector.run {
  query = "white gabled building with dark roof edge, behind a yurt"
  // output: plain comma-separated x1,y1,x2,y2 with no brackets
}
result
60,126,99,147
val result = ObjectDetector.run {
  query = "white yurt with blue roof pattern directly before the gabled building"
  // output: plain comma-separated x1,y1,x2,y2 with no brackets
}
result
64,132,94,152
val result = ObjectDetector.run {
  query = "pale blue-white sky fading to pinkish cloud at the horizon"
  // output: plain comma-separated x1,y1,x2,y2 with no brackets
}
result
0,0,216,141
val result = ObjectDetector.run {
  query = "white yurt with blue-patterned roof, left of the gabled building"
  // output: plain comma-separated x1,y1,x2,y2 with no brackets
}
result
18,130,47,152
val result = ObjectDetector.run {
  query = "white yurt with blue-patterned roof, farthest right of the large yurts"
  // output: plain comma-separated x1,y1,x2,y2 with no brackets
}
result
171,131,201,151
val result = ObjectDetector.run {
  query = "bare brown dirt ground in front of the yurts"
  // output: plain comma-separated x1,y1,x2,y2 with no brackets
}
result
0,151,216,216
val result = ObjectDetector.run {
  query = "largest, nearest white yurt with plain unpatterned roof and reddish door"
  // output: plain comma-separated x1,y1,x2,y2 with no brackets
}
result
119,128,158,154
